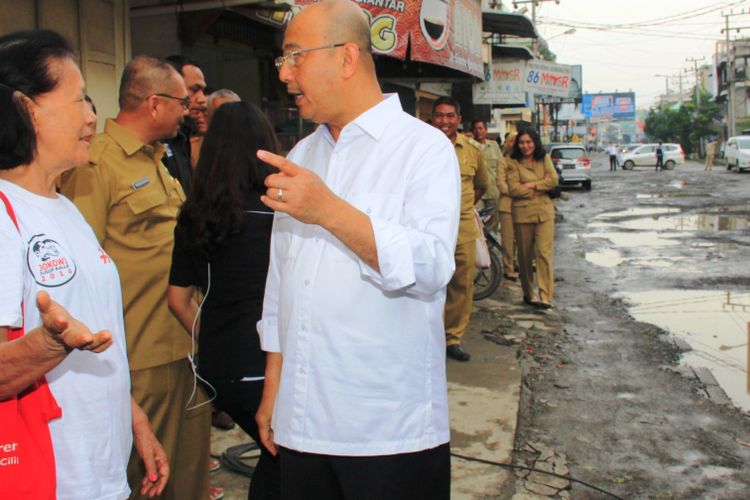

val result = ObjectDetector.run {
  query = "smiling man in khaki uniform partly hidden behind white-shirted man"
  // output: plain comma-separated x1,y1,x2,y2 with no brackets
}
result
432,97,490,361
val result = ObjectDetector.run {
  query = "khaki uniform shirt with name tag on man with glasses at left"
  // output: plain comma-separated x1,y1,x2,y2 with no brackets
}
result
60,120,191,370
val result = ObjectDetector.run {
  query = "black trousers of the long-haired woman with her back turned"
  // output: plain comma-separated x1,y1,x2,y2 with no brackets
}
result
210,380,281,500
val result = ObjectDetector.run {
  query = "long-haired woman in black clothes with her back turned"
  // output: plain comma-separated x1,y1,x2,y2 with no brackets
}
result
168,102,280,499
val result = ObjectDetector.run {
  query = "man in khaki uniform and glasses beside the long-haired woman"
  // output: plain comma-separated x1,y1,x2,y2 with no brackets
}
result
61,57,211,500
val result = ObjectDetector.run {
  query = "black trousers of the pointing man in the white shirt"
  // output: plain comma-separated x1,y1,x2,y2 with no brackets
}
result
279,443,451,500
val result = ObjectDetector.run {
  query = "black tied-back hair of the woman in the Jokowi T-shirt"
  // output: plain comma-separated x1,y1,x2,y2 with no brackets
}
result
0,30,75,170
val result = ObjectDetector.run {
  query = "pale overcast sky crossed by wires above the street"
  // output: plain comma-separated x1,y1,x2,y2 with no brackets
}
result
536,0,750,109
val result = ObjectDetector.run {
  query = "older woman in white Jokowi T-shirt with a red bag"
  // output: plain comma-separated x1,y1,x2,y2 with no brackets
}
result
0,31,169,500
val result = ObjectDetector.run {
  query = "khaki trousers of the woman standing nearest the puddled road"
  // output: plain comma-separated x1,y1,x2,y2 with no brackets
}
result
515,219,555,303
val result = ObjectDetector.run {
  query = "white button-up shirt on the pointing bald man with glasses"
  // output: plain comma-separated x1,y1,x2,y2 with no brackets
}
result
258,95,461,456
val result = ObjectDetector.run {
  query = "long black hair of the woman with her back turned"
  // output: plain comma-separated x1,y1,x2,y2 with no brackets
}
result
178,102,281,261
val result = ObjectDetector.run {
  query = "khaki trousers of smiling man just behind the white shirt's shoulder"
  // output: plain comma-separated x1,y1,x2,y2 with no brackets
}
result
445,240,476,345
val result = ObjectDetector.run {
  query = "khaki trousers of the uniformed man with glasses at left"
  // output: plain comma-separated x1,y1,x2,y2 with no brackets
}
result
128,359,211,500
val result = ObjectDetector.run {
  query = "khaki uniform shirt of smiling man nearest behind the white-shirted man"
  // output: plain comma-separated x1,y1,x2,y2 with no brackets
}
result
453,134,490,244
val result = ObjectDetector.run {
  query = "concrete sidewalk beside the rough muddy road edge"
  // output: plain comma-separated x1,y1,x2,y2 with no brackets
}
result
211,281,532,500
